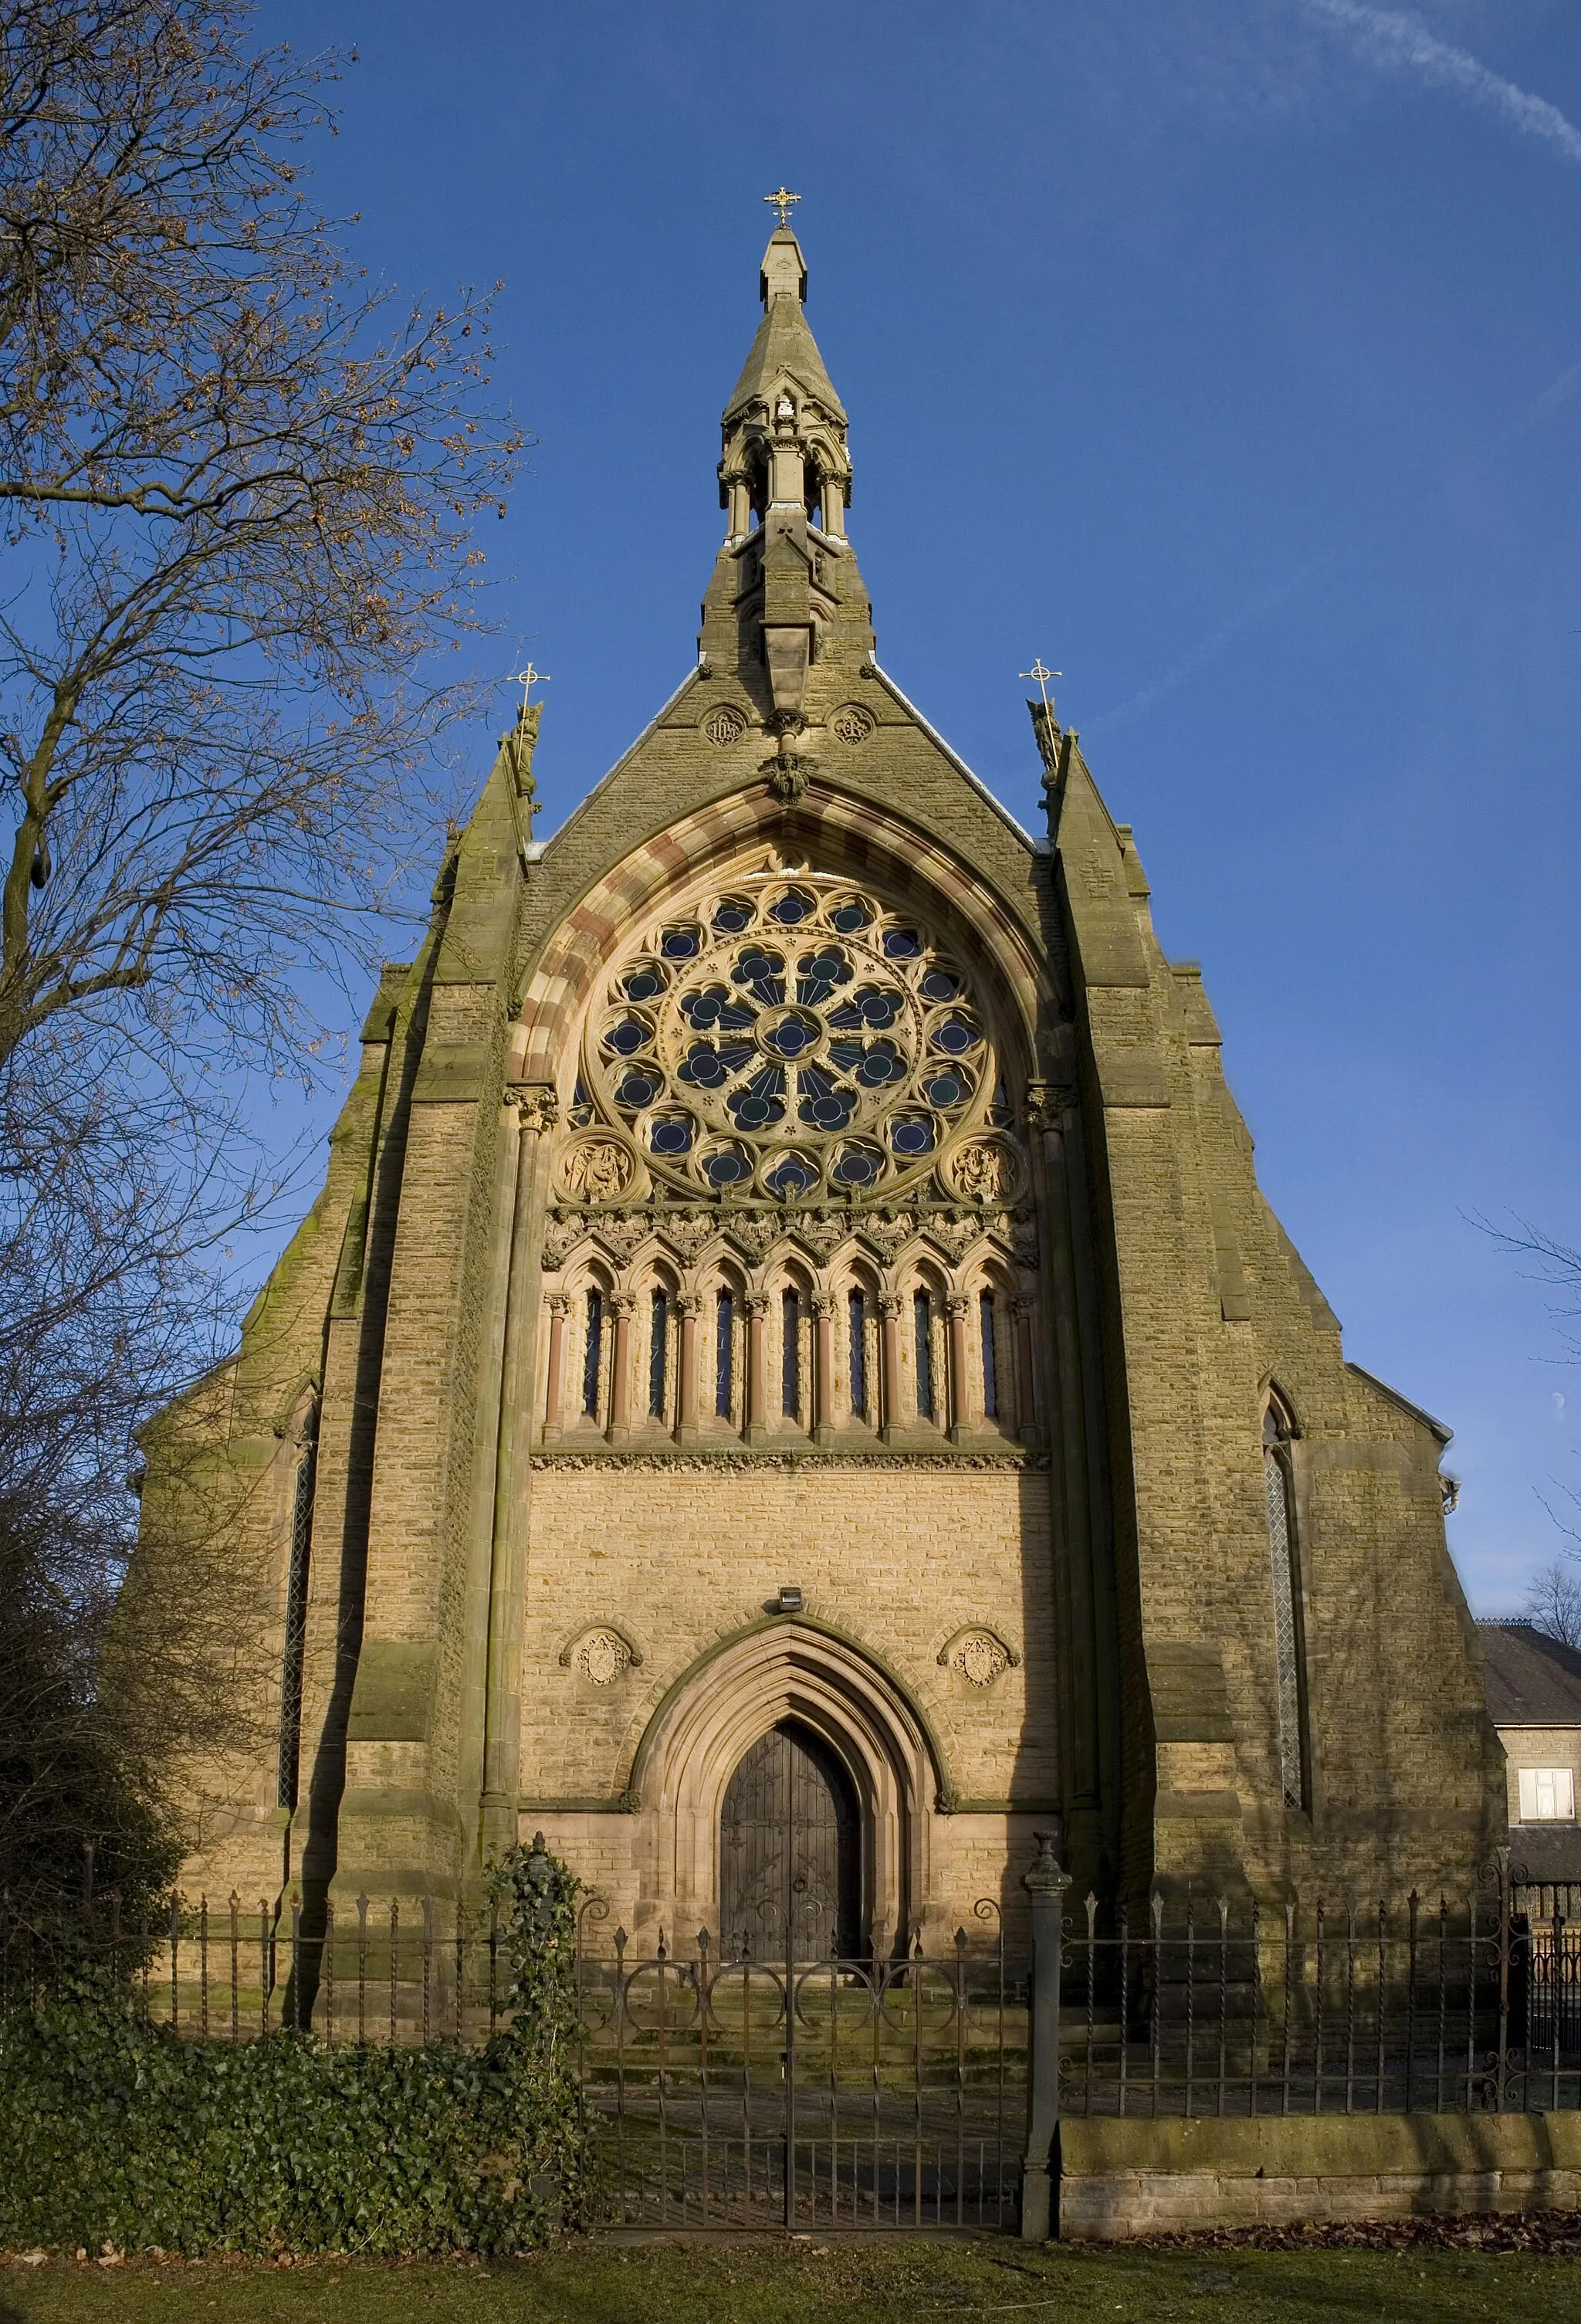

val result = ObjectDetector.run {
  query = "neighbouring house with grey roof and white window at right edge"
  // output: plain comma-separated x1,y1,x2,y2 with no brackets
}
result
1478,1622,1581,1882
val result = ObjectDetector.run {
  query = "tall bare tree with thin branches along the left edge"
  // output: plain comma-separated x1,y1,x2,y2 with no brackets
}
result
0,0,521,1908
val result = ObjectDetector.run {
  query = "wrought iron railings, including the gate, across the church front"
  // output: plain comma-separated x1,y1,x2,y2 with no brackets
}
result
0,1850,1581,2138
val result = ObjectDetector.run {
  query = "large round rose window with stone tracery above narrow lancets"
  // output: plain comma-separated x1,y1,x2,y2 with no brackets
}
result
579,872,1004,1201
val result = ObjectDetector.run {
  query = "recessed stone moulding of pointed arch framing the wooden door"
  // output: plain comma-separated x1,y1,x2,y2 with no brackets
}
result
630,1615,949,1952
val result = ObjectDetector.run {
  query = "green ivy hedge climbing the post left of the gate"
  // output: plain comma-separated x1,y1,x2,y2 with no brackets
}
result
0,1843,584,2257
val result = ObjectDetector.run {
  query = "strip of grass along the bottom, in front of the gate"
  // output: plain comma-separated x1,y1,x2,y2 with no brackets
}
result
0,2241,1581,2324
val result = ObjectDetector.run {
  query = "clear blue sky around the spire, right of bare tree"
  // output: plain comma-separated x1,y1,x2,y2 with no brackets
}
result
262,0,1581,1613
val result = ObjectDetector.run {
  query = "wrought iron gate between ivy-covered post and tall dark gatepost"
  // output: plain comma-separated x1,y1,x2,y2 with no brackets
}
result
581,1906,1027,2231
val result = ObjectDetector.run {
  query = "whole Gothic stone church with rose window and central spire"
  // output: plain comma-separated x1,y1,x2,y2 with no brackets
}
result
144,228,1505,1950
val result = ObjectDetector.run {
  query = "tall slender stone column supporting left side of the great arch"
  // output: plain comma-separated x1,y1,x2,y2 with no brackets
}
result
483,1083,560,1848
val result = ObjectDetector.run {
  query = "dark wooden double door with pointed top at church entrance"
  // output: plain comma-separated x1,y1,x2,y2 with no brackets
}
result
719,1719,865,1959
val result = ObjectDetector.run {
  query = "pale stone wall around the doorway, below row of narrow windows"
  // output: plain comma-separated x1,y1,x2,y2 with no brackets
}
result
521,1455,1058,1936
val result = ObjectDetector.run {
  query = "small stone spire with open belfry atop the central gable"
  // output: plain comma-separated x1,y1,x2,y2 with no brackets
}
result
719,225,851,725
